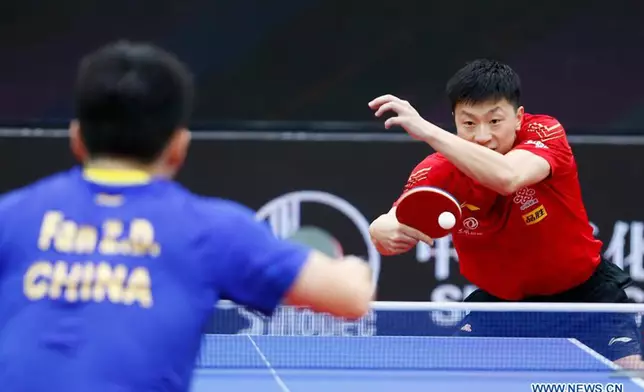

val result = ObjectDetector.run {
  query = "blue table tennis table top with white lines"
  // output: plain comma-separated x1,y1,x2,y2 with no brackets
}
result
191,335,644,392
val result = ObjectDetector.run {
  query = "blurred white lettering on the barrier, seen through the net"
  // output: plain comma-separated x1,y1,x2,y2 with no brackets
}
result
238,307,376,336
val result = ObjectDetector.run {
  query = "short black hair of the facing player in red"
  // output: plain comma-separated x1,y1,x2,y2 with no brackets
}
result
446,59,521,110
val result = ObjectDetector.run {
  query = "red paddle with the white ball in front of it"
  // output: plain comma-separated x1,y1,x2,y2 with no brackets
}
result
396,187,461,239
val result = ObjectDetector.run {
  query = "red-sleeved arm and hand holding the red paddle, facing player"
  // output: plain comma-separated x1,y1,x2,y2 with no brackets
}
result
369,154,457,256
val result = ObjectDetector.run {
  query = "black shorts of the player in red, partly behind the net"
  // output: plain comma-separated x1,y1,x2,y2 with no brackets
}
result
457,262,642,361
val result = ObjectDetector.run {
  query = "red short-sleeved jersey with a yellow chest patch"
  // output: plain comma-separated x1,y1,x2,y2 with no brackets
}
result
394,114,602,300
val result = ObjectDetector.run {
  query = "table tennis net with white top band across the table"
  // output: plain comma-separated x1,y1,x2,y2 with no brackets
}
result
197,302,644,372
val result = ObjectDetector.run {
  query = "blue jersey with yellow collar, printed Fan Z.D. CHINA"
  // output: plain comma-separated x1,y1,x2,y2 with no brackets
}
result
0,168,309,392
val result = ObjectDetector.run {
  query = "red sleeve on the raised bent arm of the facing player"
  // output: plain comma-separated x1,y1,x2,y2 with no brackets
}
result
514,116,575,177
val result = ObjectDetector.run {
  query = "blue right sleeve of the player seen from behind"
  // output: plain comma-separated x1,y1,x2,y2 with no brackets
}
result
211,207,310,315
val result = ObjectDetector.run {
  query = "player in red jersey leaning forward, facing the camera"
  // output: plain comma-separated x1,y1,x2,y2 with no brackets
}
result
369,60,642,368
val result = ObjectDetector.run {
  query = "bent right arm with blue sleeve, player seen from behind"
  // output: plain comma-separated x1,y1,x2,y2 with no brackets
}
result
211,207,374,318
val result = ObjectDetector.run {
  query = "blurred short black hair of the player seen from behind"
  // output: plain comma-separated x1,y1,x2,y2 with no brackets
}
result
74,41,194,163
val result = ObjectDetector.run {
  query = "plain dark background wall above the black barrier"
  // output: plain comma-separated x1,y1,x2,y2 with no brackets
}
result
0,0,644,134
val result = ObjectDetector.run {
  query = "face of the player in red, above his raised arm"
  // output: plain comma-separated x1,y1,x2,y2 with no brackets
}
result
454,99,523,154
